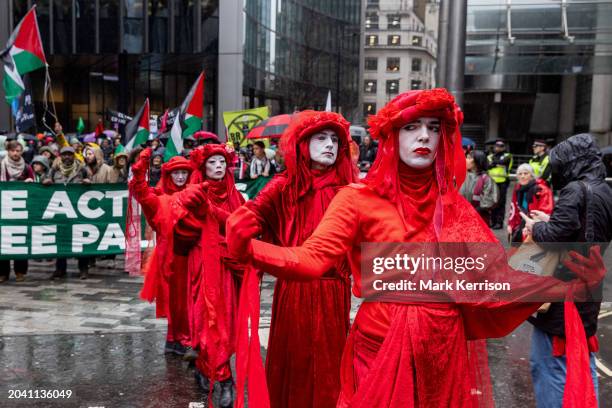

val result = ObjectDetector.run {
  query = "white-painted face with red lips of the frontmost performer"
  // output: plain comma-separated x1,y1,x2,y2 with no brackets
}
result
399,118,440,169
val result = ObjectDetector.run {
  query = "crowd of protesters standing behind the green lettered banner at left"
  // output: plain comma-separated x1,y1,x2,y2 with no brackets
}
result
0,123,283,283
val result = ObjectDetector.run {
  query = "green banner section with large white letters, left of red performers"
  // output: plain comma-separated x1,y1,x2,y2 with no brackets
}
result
0,182,128,260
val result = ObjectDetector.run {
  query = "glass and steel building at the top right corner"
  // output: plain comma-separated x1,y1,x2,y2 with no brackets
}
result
464,0,612,150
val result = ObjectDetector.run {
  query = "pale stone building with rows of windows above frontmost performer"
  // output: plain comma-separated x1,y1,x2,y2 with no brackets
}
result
361,0,438,123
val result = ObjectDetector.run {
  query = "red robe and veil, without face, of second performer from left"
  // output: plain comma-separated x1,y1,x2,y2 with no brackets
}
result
178,144,244,389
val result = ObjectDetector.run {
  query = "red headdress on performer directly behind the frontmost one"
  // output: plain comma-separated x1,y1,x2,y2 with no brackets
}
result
280,110,354,200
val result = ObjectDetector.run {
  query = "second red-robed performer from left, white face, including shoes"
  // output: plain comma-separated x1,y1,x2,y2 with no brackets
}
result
174,144,244,408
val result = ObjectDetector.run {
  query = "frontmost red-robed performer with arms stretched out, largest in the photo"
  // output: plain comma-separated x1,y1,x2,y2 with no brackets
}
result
227,89,605,408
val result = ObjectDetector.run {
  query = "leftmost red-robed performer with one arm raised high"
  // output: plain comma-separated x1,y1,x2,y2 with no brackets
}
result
128,148,193,355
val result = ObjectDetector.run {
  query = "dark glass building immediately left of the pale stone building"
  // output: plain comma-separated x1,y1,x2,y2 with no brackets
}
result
243,0,362,119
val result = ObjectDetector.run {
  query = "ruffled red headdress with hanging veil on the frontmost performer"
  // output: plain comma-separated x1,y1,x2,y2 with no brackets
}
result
365,88,465,201
